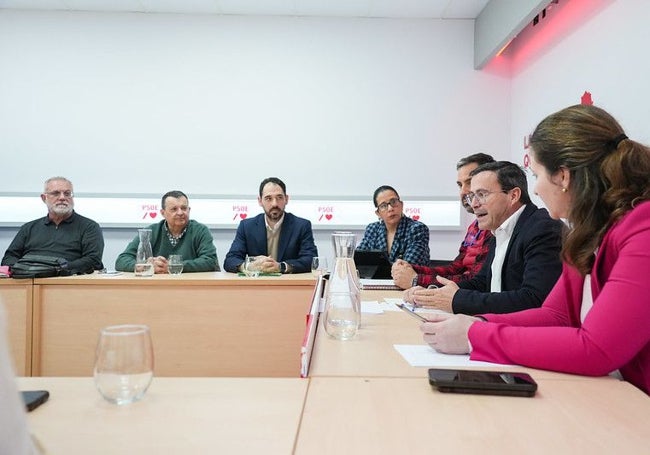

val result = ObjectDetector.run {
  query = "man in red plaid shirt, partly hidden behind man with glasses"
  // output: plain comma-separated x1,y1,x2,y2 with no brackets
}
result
392,153,494,289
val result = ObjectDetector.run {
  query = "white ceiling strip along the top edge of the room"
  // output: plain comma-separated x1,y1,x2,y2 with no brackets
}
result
0,0,489,19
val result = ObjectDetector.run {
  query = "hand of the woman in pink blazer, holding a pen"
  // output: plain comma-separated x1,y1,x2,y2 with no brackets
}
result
420,314,480,354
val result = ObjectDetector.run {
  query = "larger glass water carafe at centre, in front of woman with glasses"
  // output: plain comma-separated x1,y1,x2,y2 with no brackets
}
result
323,232,361,340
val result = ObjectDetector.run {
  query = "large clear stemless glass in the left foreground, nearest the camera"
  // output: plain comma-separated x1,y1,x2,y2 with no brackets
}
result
94,324,153,405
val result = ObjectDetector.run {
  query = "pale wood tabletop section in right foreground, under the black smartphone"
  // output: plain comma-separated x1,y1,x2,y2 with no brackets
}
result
295,377,650,455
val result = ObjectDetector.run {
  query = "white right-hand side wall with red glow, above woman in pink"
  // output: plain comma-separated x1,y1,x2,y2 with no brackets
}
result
506,0,650,175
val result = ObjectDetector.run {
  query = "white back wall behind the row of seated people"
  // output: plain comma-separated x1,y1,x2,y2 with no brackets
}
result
0,10,510,267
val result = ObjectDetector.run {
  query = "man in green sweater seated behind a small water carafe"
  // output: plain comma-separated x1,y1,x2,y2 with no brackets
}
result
115,191,220,273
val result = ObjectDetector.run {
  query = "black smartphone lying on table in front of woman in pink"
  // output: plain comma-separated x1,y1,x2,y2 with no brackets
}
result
429,368,537,397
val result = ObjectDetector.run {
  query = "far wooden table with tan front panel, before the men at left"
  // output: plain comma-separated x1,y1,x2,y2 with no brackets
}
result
0,272,316,377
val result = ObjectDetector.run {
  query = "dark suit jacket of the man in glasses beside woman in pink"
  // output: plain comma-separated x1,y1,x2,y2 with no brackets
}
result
452,203,563,314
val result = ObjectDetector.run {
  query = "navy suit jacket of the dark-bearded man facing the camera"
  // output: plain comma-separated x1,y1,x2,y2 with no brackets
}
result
223,212,318,273
